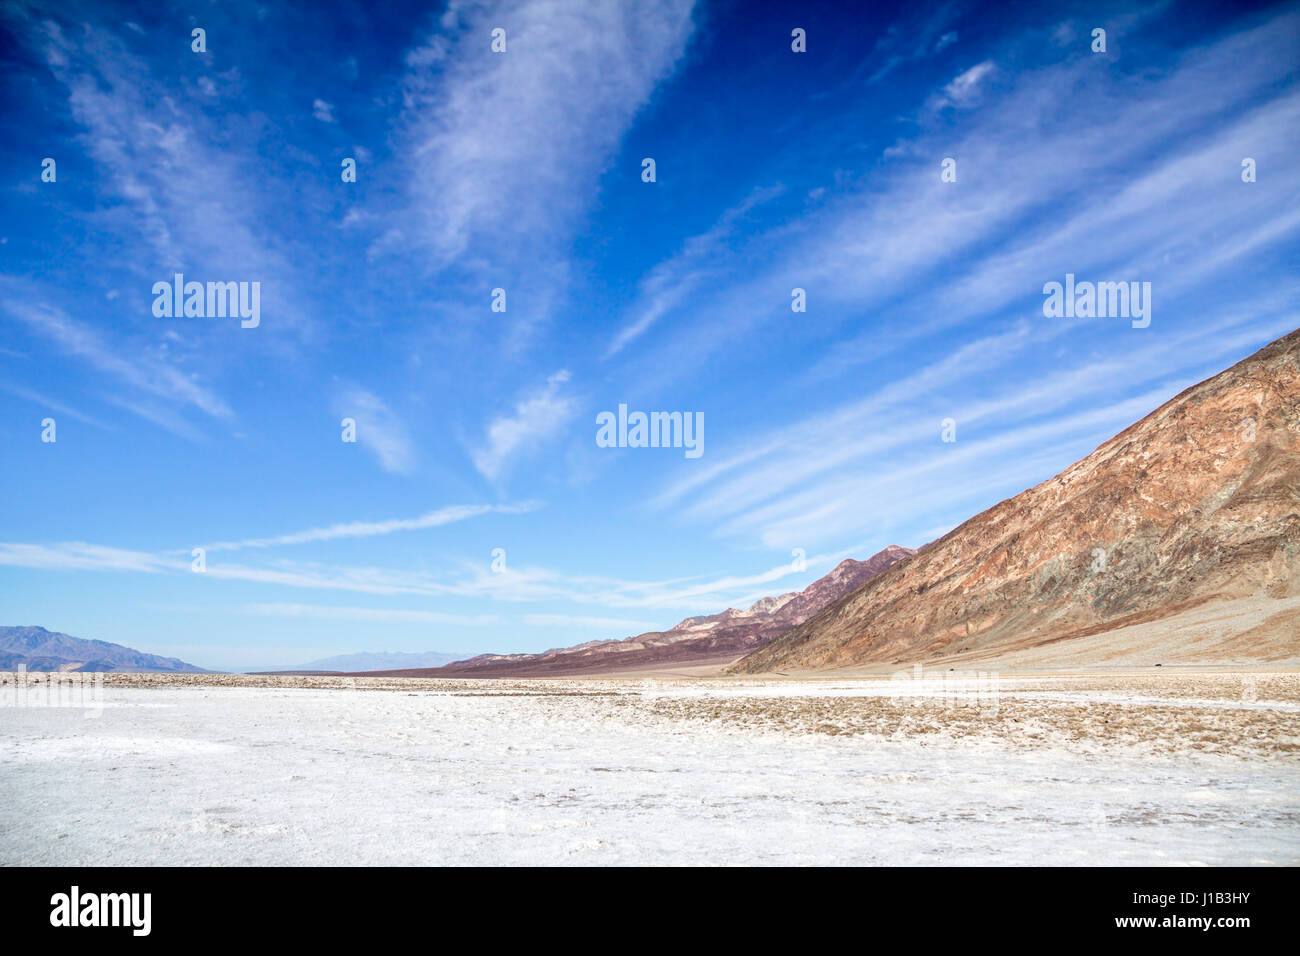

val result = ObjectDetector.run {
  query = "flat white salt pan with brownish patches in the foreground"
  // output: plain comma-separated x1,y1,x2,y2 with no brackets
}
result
0,672,1300,865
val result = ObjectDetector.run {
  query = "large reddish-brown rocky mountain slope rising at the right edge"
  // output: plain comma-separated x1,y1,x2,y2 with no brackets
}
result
728,330,1300,672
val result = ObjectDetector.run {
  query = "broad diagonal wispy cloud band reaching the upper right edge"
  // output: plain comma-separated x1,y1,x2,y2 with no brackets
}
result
613,13,1300,390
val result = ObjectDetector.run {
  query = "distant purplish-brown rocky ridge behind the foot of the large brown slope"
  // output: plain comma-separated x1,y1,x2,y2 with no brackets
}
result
372,545,913,678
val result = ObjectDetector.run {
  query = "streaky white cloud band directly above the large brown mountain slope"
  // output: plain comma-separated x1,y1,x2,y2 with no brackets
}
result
655,308,1300,548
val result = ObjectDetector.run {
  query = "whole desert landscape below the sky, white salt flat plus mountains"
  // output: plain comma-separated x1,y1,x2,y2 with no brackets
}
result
0,332,1300,865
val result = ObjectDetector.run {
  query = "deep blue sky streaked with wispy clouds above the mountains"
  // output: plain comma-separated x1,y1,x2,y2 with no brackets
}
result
0,0,1300,669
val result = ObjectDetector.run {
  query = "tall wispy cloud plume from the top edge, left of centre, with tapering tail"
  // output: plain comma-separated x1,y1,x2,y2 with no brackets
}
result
368,0,693,359
